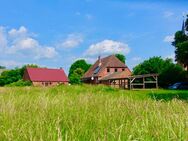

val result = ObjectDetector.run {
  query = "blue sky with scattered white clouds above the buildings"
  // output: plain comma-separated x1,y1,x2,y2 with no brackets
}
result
0,0,188,72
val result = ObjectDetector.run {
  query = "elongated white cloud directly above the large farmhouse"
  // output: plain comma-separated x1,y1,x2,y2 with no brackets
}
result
84,40,130,56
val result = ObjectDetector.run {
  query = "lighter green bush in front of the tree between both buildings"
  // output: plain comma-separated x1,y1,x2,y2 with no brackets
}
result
69,68,84,84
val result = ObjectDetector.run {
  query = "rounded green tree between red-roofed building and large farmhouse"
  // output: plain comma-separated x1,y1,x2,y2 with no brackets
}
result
69,59,91,84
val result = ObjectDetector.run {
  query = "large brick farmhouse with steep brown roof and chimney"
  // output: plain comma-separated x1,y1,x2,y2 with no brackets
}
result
82,55,132,84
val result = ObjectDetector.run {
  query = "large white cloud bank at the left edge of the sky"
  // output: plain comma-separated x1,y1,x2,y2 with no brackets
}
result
0,26,58,59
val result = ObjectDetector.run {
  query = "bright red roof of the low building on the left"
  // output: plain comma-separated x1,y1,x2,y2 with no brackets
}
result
26,68,68,82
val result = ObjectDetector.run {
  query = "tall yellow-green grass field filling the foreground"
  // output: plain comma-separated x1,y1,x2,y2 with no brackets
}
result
0,85,188,141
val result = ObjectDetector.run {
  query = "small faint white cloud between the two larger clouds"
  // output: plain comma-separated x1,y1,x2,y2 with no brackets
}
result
57,34,83,48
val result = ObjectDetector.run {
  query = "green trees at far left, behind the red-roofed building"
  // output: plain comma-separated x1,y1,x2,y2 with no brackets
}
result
0,64,38,86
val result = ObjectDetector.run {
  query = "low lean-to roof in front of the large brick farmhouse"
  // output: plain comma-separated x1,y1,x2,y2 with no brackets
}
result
99,68,131,80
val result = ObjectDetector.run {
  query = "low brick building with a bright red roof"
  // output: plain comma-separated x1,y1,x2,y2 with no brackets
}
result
23,68,69,86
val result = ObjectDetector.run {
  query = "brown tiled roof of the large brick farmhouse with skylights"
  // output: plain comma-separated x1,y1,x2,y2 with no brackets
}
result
82,55,127,78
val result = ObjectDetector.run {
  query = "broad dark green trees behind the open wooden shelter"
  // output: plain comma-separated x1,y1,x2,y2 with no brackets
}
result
133,57,186,87
